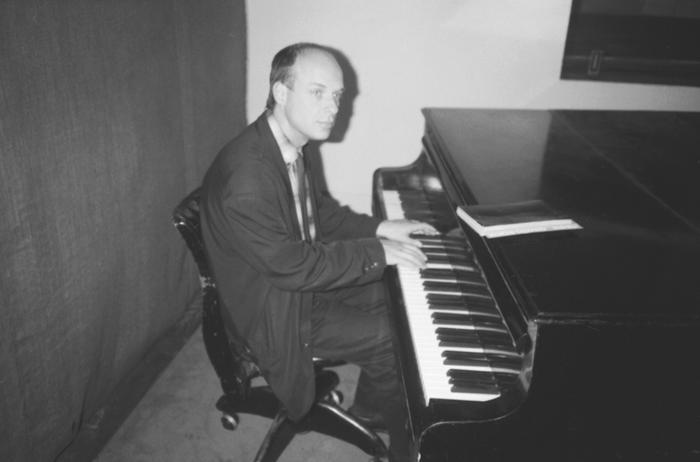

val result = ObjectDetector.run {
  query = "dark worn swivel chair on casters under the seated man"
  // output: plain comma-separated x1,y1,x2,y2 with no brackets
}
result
173,188,387,462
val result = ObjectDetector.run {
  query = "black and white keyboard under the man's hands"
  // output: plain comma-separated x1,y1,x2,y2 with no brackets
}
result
382,190,521,405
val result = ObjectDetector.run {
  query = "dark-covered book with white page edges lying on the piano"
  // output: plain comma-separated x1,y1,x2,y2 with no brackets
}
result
457,200,581,238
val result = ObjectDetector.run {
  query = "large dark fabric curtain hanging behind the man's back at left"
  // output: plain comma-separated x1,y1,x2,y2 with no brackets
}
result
0,0,246,461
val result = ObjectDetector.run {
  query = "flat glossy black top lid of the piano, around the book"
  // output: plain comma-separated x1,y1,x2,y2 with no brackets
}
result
424,109,700,323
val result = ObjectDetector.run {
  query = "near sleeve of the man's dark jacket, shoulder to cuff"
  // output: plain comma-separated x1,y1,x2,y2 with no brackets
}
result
212,164,386,291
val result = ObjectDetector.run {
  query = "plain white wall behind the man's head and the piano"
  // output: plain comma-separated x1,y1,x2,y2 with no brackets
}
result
247,0,700,212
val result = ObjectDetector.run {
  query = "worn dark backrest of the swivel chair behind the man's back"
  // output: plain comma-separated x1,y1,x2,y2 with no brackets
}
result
173,188,260,397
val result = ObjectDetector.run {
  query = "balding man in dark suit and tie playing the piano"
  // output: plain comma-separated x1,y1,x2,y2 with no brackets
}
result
201,43,435,460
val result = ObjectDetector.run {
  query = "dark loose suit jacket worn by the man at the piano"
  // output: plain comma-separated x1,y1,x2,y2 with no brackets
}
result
201,114,385,419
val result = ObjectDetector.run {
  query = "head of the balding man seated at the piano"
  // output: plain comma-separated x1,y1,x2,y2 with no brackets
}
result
267,43,343,145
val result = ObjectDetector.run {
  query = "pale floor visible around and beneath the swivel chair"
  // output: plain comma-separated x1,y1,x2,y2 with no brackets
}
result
95,329,386,462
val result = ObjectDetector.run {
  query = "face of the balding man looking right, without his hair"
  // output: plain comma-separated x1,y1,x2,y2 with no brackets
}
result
281,50,343,142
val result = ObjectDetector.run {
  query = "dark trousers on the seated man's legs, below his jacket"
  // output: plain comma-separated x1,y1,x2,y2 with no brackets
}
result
312,282,409,461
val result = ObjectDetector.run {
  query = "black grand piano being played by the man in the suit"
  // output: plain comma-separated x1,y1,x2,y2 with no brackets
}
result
373,108,700,462
